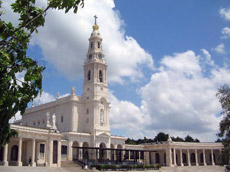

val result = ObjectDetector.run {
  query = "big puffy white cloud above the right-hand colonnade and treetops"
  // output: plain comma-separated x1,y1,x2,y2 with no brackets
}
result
139,50,230,141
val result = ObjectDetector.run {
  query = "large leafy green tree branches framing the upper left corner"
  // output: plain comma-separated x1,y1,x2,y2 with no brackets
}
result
0,0,84,146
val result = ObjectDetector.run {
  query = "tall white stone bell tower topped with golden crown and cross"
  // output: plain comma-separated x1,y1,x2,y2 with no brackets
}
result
82,16,110,136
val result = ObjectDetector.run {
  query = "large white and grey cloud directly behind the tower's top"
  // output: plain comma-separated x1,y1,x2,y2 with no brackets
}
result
30,0,153,83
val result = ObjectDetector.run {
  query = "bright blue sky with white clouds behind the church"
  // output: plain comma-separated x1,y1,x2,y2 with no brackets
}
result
3,0,230,141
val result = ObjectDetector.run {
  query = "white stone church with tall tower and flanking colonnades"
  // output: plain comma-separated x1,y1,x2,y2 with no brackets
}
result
0,18,222,168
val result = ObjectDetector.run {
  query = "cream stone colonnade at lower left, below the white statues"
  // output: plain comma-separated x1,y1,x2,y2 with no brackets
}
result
2,137,61,167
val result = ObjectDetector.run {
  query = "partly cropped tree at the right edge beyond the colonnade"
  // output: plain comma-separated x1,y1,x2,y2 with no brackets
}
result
217,85,230,165
